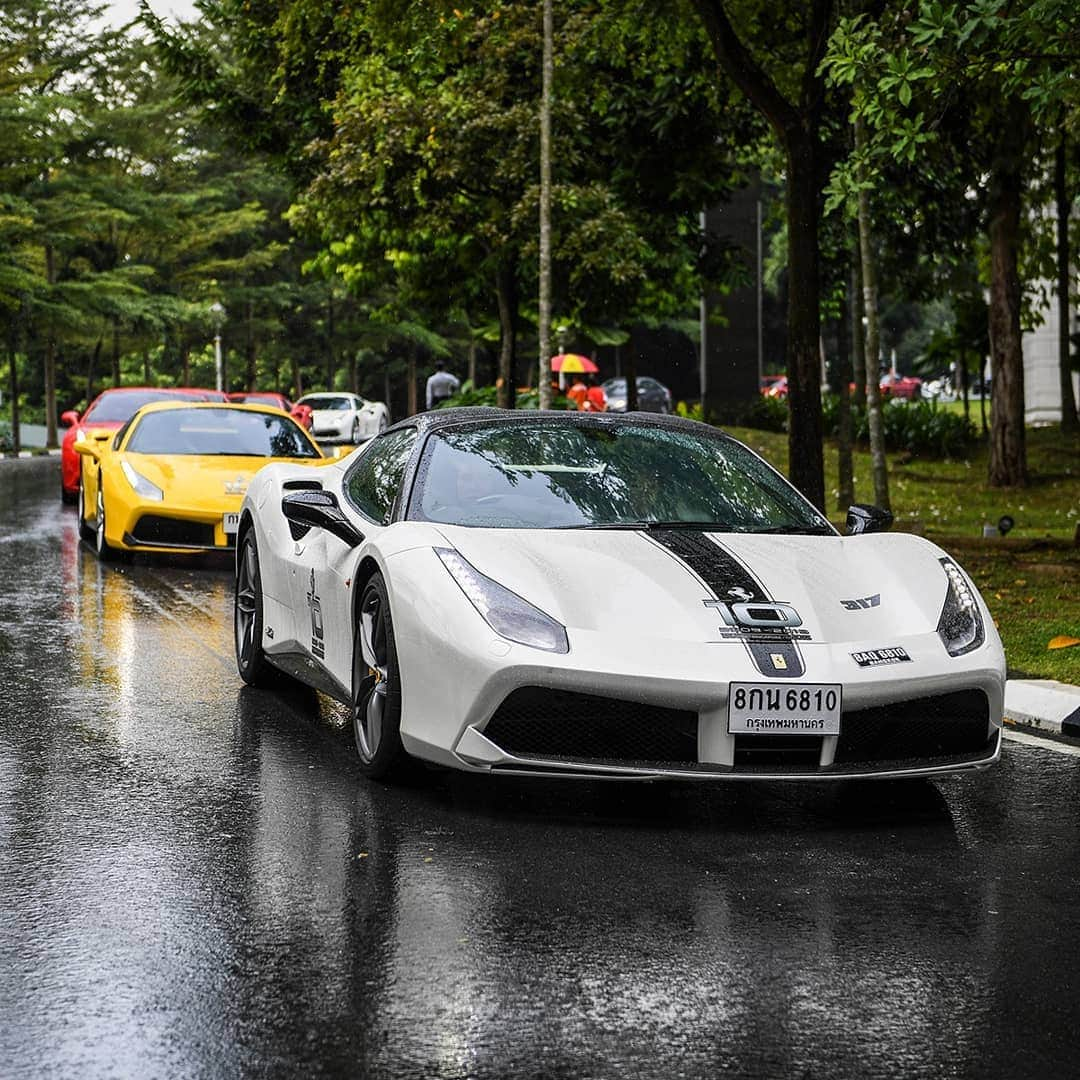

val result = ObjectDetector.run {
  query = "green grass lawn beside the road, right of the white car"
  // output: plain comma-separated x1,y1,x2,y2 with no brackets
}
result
726,416,1080,685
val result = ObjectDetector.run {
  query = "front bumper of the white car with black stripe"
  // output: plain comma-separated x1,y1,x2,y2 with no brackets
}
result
391,552,1004,780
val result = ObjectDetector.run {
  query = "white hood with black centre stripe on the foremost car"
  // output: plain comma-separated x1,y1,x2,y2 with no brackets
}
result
440,526,946,644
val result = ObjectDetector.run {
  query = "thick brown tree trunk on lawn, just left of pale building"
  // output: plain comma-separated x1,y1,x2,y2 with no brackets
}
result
989,97,1030,487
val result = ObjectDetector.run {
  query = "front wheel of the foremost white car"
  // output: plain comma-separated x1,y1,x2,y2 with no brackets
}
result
352,573,408,780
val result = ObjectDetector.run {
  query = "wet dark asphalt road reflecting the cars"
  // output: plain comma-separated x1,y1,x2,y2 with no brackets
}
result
0,459,1080,1078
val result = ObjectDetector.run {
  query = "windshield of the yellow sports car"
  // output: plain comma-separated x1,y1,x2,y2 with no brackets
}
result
126,408,320,458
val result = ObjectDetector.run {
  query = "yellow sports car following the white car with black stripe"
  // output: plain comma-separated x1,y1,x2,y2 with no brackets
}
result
75,402,330,561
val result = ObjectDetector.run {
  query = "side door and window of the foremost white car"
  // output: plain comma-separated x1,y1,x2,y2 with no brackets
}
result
292,428,417,688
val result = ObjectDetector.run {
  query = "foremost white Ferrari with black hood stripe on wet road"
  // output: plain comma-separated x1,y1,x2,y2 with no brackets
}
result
235,408,1005,780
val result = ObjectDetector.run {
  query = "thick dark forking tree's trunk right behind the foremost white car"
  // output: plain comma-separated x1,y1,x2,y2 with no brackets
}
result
786,129,825,512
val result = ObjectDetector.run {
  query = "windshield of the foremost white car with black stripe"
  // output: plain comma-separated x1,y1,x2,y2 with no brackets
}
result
408,422,834,535
